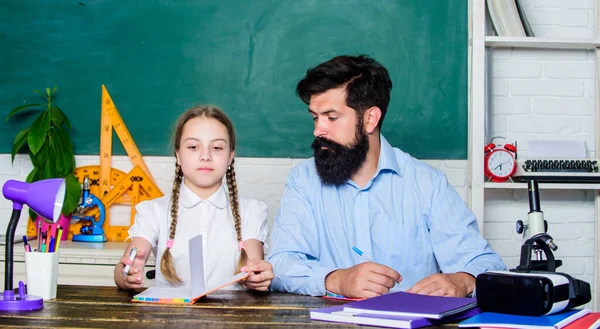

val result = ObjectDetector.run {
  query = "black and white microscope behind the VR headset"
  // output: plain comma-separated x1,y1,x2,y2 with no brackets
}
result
511,180,562,273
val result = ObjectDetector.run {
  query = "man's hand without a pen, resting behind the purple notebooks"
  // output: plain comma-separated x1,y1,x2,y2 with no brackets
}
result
406,272,475,297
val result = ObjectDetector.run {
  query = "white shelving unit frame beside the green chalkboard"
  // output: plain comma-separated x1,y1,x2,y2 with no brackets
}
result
467,0,600,311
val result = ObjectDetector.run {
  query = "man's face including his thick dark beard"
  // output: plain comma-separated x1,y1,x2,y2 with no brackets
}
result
308,88,369,185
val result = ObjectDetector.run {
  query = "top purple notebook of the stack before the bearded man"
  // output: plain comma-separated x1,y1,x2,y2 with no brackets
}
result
344,291,477,319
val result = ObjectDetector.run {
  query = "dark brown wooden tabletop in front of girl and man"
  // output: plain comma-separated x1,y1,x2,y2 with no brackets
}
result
0,285,456,329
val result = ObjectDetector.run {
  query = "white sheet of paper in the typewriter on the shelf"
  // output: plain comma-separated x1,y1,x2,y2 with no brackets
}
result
527,140,587,160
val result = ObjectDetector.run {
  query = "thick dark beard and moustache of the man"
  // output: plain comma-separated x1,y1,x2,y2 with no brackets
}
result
311,124,369,185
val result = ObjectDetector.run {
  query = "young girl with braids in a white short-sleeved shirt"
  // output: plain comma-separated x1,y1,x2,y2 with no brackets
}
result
114,106,273,290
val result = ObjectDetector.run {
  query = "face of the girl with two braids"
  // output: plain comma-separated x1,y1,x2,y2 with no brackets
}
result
176,117,235,199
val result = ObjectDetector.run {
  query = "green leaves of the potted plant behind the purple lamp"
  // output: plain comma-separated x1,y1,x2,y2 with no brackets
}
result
6,87,81,236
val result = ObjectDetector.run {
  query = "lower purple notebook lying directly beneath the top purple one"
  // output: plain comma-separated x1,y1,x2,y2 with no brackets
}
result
310,305,481,329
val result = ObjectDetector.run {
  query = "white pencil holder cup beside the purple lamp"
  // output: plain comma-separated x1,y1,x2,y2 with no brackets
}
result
25,252,58,300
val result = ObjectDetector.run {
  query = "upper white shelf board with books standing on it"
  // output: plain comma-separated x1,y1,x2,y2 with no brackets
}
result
485,36,600,49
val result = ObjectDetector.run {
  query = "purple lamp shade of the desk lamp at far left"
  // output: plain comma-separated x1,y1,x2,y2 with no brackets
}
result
2,178,65,222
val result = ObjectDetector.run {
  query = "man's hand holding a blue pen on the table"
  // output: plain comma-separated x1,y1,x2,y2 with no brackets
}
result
325,262,402,298
